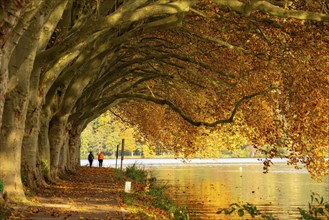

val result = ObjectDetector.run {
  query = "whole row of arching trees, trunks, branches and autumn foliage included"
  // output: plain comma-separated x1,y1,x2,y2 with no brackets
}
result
0,0,329,200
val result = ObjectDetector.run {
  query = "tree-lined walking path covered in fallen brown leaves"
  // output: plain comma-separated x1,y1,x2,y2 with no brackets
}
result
5,167,126,220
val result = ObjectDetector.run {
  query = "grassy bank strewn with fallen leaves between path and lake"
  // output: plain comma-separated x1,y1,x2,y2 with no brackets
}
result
114,164,193,220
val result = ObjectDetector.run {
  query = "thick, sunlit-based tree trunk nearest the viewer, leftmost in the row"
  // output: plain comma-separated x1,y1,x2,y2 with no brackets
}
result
0,16,41,200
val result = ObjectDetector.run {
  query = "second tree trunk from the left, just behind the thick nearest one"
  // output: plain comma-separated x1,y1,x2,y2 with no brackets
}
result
22,1,67,190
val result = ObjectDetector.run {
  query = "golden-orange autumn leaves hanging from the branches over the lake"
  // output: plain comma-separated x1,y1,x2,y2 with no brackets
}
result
111,1,329,176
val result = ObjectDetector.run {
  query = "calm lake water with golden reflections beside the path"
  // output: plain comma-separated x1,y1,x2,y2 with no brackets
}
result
81,158,329,219
